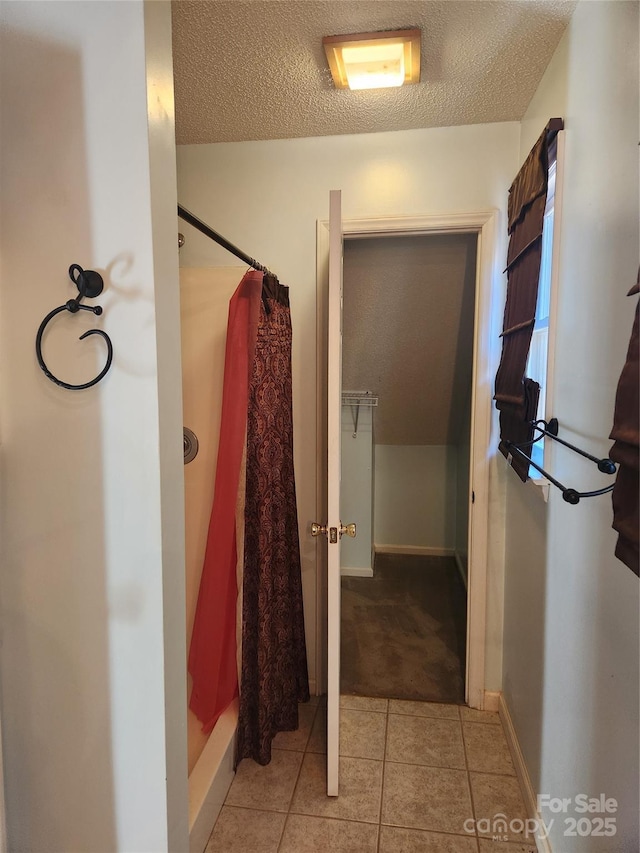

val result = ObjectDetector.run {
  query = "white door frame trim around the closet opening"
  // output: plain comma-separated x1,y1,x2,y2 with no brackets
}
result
316,209,498,709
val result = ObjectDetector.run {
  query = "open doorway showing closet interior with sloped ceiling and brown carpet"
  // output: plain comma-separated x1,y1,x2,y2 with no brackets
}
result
340,232,477,703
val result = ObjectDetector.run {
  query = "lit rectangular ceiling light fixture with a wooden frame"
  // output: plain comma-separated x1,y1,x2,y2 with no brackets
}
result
322,30,421,89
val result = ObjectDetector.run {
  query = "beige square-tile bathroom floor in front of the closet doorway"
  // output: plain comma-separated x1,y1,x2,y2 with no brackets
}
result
206,696,536,853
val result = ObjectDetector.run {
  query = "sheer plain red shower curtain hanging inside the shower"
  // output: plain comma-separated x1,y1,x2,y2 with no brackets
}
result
189,270,262,732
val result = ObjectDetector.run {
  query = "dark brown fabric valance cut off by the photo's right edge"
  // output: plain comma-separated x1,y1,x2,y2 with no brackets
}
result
609,271,640,576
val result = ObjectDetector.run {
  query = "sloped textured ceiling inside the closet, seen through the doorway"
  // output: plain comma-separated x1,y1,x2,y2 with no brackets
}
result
342,234,477,445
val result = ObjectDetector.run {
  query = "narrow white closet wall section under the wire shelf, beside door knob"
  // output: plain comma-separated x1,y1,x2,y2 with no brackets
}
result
340,405,375,571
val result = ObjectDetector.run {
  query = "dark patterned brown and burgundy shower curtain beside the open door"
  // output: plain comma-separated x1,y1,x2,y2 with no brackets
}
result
236,274,309,764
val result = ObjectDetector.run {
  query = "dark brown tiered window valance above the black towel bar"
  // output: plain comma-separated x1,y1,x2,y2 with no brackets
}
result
494,118,563,481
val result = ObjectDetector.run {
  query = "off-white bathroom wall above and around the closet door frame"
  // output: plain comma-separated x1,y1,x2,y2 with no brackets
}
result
178,122,519,689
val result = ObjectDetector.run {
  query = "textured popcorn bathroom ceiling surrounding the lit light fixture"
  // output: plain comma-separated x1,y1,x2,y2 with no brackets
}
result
172,0,575,144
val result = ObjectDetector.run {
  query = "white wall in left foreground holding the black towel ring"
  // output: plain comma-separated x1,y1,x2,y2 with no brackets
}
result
0,2,188,853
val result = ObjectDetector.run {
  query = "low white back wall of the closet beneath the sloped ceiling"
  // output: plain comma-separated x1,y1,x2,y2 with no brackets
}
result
374,444,457,551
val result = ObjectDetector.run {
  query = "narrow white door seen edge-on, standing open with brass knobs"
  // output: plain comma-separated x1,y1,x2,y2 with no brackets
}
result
327,190,342,797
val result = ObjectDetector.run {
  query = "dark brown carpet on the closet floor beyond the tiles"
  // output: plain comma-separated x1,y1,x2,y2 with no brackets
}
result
340,554,466,703
